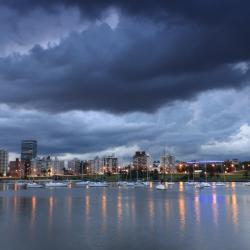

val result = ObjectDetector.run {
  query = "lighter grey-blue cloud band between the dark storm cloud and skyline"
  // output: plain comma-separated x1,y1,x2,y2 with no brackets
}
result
0,88,250,160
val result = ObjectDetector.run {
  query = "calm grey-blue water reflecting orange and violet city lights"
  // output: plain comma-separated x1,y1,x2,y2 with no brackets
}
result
0,183,250,250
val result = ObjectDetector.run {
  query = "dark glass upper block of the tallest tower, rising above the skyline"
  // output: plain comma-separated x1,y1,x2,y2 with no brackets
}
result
21,140,37,161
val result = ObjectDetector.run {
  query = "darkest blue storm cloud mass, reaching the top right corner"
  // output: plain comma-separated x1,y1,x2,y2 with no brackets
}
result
0,0,250,112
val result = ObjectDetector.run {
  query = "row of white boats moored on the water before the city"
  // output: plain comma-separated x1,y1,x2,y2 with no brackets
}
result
5,181,250,190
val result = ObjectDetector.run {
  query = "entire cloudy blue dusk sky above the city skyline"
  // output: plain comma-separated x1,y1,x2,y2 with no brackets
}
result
0,0,250,160
